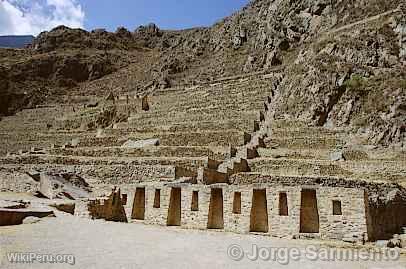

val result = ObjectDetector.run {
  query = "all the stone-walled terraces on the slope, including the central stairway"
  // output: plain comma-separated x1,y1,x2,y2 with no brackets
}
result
0,68,406,193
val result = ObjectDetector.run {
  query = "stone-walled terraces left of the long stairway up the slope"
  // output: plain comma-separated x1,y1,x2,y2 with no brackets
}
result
0,71,282,193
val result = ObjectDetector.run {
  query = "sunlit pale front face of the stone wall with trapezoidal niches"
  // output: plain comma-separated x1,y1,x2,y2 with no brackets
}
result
119,183,368,241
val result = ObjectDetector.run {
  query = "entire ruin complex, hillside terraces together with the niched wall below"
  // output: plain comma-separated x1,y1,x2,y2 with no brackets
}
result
0,70,406,246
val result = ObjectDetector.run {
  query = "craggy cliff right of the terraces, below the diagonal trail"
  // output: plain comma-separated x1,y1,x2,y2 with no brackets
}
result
266,4,406,147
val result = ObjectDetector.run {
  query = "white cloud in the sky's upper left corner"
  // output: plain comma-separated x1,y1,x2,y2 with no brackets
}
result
0,0,85,35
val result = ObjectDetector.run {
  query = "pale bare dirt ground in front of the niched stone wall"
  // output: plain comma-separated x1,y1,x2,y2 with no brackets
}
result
0,209,406,269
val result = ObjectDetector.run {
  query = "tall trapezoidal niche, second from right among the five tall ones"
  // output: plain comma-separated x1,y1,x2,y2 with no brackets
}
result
250,190,269,233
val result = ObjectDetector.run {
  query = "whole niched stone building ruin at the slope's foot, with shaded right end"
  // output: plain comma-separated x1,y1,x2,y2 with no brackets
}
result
77,174,406,243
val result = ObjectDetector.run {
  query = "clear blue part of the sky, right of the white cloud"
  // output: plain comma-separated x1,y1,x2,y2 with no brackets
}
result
80,0,249,30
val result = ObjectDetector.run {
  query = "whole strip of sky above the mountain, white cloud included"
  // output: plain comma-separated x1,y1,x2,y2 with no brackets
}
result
0,0,249,35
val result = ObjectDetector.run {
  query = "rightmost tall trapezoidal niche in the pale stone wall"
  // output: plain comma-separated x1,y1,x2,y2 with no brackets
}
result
300,190,320,233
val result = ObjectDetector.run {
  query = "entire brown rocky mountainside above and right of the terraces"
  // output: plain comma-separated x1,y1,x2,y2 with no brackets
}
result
0,0,406,146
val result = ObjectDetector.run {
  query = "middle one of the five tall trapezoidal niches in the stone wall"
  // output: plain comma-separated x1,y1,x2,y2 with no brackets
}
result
207,189,224,229
